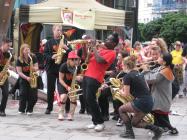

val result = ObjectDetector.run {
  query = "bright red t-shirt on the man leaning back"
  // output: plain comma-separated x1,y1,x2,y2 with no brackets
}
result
85,49,116,83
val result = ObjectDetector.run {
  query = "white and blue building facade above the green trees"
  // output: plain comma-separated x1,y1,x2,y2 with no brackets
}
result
138,0,187,23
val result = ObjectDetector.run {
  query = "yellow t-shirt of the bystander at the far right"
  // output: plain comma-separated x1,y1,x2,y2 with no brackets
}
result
171,49,183,65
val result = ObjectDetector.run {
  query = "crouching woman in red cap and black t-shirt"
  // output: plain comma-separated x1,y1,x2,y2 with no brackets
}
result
57,51,81,121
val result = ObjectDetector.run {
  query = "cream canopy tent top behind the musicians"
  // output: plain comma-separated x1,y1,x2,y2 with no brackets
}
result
19,0,126,30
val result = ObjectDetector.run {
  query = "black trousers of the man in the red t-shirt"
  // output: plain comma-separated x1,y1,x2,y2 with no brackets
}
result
83,76,104,125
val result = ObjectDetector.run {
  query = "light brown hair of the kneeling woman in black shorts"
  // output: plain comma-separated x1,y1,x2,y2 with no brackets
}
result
123,55,137,69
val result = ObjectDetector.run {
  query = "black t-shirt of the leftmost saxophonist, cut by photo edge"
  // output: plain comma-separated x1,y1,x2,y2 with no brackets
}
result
0,49,14,71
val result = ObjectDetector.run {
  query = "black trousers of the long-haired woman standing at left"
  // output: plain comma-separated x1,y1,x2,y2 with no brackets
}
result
19,79,38,112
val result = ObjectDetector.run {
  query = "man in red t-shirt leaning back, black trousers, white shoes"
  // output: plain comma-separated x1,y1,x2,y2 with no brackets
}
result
83,33,119,131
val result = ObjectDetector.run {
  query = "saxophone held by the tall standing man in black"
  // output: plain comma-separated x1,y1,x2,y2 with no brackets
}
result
55,35,66,64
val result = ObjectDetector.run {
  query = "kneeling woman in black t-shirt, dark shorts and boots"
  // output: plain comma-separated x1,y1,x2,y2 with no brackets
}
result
119,56,162,140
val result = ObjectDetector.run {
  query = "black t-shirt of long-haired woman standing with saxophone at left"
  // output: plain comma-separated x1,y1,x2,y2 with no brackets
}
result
16,56,37,76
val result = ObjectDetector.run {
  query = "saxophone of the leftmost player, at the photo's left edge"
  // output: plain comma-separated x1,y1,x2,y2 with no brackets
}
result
0,52,12,86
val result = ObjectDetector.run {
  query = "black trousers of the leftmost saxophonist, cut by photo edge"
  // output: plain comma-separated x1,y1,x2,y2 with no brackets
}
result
0,80,8,112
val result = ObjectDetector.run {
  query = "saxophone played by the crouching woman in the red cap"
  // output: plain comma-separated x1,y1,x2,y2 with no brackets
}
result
68,66,80,102
